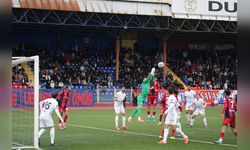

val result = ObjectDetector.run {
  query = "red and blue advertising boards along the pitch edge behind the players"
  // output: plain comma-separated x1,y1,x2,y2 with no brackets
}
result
12,88,230,108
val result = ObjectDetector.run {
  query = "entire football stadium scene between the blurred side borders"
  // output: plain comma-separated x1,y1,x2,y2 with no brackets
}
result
11,0,238,150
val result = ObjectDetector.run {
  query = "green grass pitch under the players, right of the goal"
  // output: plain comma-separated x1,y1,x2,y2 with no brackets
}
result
34,108,237,150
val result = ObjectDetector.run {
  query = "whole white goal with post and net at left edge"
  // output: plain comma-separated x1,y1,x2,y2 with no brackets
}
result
12,56,39,149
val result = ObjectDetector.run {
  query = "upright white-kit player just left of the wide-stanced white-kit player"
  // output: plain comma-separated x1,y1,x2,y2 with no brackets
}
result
184,87,196,124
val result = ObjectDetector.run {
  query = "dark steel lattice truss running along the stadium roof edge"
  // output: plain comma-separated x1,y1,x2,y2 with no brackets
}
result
12,8,237,34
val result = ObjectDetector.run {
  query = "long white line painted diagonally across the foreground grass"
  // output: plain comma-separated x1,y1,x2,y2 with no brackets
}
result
68,124,238,147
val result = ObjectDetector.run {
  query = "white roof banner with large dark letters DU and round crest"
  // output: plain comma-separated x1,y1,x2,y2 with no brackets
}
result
171,0,237,21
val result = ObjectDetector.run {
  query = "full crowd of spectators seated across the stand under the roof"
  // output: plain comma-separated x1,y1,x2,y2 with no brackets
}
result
12,43,237,89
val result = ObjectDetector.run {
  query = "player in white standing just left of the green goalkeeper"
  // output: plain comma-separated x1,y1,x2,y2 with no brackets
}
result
114,87,128,131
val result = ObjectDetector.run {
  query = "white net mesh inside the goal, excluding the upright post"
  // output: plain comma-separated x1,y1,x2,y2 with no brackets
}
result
12,56,38,149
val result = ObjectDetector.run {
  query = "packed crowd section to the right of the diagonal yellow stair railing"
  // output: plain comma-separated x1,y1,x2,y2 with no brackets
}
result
168,50,237,89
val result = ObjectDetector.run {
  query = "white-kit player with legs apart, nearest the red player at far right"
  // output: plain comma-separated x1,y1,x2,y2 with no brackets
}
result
190,94,207,128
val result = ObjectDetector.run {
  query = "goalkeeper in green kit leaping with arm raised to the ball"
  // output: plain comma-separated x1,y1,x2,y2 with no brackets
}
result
128,68,155,123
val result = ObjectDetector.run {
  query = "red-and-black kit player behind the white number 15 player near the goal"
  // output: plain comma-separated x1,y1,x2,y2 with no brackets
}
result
57,86,71,129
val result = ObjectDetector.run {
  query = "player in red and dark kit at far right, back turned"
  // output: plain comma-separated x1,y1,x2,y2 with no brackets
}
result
214,90,238,144
